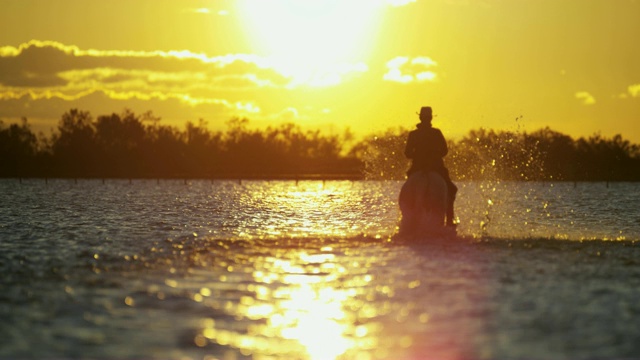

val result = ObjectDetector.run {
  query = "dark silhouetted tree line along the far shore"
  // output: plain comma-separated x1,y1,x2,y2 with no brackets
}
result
0,109,640,181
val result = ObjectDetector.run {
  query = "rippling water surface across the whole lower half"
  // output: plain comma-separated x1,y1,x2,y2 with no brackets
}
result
0,179,640,360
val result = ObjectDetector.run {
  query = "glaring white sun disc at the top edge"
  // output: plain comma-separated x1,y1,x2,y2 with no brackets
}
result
237,0,381,84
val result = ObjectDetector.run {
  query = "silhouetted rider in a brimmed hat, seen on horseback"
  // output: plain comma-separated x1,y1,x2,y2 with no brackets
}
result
404,106,458,226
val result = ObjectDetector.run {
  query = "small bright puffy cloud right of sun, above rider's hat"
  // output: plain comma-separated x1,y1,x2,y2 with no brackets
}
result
383,56,438,84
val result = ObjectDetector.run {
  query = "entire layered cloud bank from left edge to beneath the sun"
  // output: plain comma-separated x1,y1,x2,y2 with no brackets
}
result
0,40,380,131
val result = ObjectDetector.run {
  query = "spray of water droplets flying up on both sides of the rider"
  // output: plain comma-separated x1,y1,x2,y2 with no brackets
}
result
356,117,636,239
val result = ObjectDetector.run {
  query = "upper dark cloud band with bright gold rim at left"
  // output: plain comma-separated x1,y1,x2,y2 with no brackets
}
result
0,41,288,91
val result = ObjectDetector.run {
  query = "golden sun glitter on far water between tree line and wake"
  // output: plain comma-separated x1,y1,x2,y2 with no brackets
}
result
232,181,398,239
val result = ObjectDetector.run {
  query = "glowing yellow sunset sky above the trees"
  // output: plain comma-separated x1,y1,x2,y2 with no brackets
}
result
0,0,640,144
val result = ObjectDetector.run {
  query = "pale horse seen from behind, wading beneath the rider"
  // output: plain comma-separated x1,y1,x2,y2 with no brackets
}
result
399,171,448,237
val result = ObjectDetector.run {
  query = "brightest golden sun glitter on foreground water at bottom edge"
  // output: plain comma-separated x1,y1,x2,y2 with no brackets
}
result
194,249,379,360
